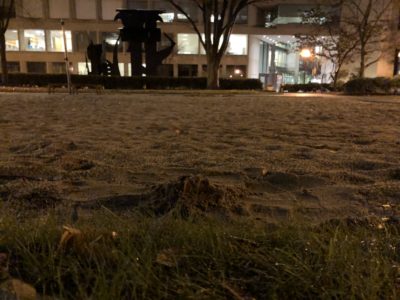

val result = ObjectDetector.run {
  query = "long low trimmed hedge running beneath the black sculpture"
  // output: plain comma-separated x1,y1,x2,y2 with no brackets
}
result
7,73,262,90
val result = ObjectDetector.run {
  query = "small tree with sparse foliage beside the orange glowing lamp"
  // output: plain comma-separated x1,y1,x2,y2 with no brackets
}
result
297,5,357,88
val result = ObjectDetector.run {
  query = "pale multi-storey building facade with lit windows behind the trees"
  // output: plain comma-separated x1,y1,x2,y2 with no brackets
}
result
6,0,400,83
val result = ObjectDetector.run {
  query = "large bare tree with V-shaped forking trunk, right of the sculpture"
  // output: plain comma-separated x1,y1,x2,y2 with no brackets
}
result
165,0,259,89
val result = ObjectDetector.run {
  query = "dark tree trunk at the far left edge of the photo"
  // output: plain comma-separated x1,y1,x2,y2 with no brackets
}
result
0,0,15,84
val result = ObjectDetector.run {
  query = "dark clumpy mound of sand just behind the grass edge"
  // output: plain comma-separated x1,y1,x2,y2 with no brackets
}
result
76,176,248,218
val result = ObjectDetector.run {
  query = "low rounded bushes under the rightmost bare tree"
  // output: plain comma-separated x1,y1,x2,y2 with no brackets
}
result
344,77,400,95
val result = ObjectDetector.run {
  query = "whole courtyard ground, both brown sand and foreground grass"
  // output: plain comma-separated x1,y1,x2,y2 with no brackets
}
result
0,92,400,299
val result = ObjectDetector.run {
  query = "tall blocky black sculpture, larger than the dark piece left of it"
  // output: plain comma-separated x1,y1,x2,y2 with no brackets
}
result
114,9,175,76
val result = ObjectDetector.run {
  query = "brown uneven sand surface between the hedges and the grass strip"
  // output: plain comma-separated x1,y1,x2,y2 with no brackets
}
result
0,92,400,221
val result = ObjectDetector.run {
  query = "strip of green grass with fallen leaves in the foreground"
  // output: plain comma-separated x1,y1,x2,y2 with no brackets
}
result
0,210,400,299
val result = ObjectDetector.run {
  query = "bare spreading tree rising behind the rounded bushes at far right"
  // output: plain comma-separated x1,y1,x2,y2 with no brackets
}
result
341,0,393,78
